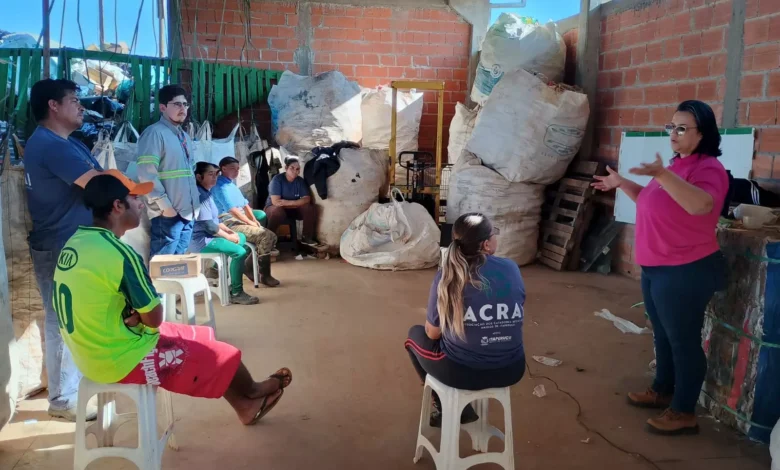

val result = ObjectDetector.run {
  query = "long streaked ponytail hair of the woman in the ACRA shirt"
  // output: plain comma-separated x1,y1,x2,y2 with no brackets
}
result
436,212,494,339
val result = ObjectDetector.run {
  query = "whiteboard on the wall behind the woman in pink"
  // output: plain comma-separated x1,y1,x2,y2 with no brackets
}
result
615,127,755,224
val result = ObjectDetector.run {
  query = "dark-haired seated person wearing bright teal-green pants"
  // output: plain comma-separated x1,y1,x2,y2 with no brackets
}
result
188,162,260,305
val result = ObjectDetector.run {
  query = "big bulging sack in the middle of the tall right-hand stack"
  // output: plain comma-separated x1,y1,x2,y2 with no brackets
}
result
466,70,590,184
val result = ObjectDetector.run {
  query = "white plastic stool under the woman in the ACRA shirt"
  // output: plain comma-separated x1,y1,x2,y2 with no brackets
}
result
414,375,515,470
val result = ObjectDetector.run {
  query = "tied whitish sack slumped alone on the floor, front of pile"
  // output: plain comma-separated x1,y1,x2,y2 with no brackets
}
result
341,190,441,271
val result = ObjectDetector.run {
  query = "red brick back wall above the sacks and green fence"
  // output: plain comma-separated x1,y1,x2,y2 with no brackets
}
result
182,0,471,153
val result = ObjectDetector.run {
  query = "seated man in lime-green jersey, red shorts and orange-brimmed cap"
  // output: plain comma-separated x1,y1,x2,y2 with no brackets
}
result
54,170,292,425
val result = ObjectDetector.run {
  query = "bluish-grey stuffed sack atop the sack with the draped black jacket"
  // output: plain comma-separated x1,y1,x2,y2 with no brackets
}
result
268,71,363,156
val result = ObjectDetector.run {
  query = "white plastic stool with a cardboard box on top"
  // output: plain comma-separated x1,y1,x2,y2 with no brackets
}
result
154,274,217,335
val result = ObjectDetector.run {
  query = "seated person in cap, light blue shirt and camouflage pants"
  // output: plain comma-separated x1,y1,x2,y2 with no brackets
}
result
211,157,279,287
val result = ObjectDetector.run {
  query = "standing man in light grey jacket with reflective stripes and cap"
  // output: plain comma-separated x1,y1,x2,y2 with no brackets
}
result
137,85,200,256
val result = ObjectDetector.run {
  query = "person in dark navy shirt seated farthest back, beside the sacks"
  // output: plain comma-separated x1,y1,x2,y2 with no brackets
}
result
265,157,318,245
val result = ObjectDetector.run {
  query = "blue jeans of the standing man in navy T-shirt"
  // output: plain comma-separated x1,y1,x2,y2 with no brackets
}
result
30,247,81,410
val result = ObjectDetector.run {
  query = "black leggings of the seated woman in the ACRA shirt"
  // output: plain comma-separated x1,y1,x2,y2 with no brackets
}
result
405,325,525,390
